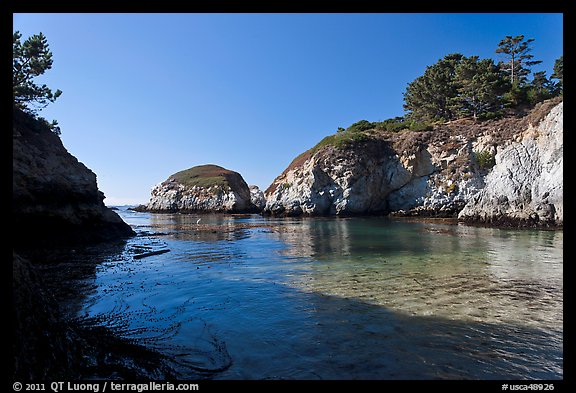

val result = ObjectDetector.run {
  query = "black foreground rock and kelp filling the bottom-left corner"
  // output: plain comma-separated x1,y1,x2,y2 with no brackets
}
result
11,254,178,381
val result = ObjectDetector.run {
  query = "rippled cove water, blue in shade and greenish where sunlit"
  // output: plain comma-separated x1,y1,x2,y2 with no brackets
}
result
79,209,563,379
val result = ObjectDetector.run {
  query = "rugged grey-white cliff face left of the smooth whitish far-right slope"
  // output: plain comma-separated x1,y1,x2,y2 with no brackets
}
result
264,130,482,216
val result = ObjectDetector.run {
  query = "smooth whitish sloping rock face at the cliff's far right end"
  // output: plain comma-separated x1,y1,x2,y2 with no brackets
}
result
459,103,564,226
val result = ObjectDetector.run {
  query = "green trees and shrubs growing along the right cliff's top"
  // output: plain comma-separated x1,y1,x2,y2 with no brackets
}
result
306,35,564,155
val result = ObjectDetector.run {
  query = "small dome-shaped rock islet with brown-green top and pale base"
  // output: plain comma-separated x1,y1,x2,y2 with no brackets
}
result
142,165,260,213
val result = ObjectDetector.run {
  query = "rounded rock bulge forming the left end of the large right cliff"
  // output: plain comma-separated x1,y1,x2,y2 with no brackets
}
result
265,140,436,216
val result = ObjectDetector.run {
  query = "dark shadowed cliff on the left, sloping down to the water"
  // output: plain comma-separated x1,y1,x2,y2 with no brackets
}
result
12,110,134,247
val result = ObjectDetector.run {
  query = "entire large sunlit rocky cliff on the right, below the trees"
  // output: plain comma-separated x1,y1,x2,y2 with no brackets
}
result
264,100,563,227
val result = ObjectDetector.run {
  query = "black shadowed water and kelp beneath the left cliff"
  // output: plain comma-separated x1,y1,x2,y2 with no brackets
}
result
11,242,229,380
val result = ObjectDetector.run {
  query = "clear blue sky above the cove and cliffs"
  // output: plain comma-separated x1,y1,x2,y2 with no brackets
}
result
13,13,563,205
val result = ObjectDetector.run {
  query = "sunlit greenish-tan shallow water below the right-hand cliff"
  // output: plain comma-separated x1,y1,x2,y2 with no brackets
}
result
275,219,563,329
